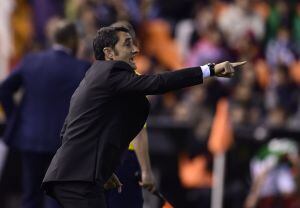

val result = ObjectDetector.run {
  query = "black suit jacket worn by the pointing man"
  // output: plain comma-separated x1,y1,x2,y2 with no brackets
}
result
43,61,203,184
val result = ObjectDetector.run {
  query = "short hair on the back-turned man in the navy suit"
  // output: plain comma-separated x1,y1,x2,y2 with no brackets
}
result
53,20,78,45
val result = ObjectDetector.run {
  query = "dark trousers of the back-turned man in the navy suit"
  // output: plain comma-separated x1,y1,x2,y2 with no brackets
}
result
21,151,60,208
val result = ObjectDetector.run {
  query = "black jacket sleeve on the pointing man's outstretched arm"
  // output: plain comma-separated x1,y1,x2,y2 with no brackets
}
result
108,63,203,95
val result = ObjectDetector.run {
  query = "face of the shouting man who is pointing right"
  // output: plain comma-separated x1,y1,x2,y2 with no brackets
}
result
113,32,139,69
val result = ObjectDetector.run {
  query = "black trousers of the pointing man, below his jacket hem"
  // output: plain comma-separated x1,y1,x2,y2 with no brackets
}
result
46,181,106,208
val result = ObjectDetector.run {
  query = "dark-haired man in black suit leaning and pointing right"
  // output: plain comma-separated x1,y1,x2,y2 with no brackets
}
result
43,24,244,208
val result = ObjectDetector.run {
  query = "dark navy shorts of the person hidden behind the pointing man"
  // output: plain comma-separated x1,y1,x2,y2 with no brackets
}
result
106,150,143,208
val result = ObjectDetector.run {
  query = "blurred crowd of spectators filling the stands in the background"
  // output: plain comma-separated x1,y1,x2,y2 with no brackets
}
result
0,0,300,208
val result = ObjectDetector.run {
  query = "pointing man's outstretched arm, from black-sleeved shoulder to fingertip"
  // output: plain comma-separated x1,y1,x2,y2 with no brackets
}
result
108,61,246,95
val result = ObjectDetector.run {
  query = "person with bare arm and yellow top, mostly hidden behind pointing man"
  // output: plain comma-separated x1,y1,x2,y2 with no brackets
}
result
105,21,155,208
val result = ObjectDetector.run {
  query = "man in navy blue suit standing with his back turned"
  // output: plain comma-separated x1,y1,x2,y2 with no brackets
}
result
0,20,90,208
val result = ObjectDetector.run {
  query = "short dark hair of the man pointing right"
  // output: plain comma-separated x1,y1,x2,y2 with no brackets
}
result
93,27,129,60
